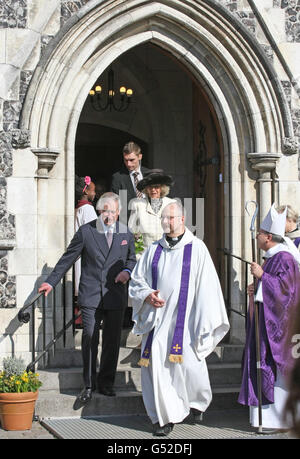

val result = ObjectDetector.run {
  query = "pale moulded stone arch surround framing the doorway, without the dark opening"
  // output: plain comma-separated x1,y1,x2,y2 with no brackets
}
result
17,0,298,342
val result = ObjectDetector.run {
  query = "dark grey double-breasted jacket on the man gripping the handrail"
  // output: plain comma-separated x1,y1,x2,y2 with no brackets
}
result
46,220,136,309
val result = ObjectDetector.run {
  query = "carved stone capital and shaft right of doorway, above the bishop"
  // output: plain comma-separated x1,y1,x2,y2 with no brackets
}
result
247,152,281,219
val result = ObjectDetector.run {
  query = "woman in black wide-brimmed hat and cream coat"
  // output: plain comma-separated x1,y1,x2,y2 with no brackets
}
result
128,169,175,255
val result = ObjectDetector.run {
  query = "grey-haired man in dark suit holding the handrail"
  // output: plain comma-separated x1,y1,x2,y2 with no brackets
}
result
39,192,136,403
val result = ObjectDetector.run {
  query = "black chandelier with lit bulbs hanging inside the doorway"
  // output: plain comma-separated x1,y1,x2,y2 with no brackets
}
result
89,68,133,112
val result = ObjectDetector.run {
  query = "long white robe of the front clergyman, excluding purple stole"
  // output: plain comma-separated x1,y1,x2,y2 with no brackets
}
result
129,228,229,426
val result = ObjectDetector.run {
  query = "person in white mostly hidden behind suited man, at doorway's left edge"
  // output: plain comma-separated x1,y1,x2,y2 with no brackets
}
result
74,176,97,328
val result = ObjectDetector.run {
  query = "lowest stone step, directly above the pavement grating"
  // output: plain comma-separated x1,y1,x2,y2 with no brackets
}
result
35,385,244,419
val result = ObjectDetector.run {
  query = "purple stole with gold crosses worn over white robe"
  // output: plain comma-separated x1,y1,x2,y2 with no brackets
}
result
139,243,192,367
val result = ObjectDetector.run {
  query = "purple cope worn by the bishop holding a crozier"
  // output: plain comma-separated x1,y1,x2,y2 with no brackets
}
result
238,251,300,406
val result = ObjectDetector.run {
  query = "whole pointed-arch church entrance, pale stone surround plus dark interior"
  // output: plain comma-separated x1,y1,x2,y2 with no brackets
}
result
20,0,293,340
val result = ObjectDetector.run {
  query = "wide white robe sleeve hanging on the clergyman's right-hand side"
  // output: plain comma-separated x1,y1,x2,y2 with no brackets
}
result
194,244,229,360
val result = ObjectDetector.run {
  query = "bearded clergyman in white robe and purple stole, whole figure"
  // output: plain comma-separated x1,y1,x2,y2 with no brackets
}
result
129,201,229,436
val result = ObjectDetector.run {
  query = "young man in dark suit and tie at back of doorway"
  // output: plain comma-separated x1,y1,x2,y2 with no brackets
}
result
111,142,150,218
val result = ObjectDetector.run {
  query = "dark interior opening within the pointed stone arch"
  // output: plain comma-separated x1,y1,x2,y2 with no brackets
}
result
75,43,223,274
